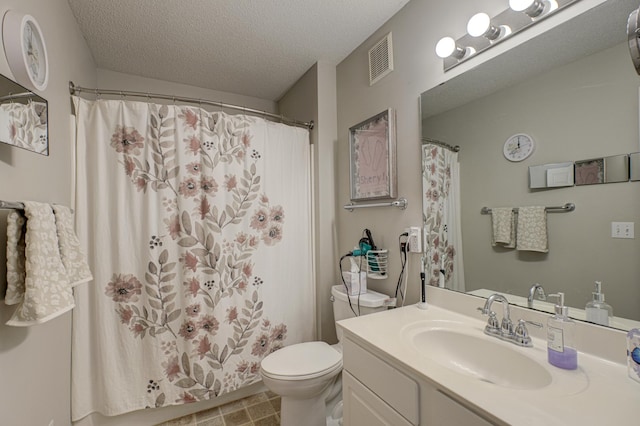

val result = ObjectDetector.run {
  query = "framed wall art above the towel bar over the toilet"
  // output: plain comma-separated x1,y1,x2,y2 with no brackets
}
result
349,108,397,201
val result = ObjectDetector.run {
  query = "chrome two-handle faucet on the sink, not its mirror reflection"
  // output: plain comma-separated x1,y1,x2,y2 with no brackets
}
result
478,294,542,347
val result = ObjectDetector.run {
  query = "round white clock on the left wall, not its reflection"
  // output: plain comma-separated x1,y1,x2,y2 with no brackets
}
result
2,10,49,90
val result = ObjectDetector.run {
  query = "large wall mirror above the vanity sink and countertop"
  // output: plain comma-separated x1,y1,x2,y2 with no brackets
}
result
421,0,640,329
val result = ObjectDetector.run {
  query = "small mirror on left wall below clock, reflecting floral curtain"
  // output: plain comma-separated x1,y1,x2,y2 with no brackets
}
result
0,75,49,155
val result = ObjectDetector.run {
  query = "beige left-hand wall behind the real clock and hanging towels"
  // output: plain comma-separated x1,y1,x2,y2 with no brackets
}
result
0,0,96,426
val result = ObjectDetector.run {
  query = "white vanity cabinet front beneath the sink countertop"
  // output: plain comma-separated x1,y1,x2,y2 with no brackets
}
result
342,333,500,426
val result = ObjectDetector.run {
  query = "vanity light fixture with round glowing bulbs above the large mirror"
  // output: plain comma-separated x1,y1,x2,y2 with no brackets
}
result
436,0,580,73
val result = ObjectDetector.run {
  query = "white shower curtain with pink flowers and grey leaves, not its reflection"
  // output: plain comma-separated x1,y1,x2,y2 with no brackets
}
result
72,97,315,421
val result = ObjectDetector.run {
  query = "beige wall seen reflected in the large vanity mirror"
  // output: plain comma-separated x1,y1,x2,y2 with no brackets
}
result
424,43,640,320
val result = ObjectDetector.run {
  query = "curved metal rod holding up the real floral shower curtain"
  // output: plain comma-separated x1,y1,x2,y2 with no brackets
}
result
69,81,315,130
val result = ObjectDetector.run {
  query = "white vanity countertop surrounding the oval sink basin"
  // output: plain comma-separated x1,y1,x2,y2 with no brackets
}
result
338,305,640,426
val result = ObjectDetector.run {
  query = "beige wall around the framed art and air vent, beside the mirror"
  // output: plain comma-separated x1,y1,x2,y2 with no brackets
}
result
335,0,616,302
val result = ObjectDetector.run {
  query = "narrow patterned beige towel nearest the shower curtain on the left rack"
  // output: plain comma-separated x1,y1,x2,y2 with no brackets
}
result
53,204,93,287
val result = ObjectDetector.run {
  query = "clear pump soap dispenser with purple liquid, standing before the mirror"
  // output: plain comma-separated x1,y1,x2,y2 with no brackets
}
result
547,293,578,370
